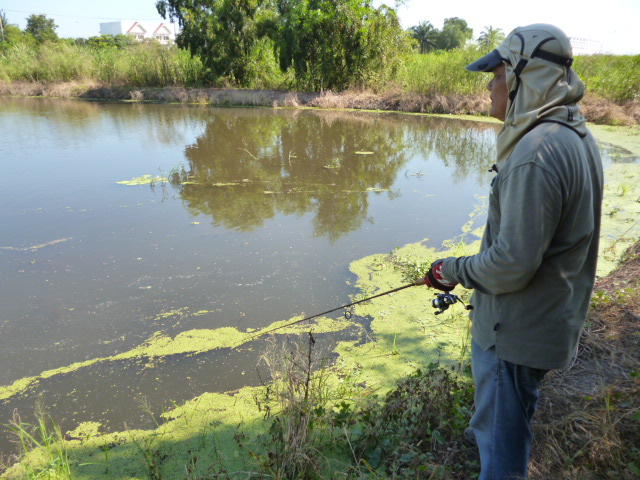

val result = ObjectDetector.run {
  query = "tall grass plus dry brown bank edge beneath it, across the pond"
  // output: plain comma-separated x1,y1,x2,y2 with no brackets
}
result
0,41,640,125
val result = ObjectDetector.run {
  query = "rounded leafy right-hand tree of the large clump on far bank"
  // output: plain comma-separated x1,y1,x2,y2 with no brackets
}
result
277,0,407,90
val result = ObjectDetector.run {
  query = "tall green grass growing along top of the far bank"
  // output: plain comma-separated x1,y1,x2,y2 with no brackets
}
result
0,40,640,103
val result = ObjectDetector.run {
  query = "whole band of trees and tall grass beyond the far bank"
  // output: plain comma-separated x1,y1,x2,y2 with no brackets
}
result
0,5,640,103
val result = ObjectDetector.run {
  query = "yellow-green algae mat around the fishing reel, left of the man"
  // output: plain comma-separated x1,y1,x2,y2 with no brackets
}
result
336,236,478,390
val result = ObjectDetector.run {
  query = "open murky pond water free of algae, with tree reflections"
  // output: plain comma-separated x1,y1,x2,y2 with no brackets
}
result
0,98,616,452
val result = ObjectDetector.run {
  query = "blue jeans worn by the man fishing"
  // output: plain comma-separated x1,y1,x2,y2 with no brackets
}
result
469,341,547,480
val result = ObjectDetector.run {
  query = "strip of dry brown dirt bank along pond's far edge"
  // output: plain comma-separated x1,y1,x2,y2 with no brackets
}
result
0,82,640,125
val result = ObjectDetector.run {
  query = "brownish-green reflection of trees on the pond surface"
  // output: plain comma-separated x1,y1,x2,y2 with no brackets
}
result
171,110,495,241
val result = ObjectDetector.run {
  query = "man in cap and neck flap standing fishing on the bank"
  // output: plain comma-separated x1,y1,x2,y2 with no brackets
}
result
423,24,603,480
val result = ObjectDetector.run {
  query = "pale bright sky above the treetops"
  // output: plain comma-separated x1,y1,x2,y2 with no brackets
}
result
0,0,640,54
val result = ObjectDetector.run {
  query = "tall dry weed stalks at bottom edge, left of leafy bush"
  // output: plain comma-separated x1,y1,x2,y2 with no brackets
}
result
252,333,354,479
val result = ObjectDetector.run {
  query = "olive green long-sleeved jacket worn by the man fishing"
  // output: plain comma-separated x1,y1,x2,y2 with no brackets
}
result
443,122,603,369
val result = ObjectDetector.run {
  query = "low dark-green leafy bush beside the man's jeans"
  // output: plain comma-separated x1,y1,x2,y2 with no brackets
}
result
357,364,478,478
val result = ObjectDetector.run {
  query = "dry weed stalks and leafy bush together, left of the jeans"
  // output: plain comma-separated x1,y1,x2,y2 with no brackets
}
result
251,336,478,479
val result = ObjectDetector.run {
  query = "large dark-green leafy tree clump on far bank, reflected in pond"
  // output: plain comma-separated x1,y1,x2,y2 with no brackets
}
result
156,0,407,89
